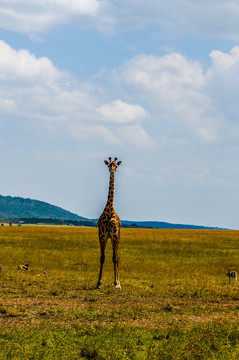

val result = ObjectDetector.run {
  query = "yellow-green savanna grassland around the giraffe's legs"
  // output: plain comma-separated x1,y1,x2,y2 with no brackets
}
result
0,226,239,360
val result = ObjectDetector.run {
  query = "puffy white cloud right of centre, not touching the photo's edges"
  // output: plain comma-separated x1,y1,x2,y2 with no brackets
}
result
115,53,204,98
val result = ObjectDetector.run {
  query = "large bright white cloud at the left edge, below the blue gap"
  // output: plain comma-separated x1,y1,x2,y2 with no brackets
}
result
0,41,86,120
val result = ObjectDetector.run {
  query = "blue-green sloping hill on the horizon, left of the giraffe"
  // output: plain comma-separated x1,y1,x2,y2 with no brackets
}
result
0,195,88,221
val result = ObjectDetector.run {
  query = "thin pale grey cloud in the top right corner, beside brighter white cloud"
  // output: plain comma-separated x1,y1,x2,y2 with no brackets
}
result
103,0,239,40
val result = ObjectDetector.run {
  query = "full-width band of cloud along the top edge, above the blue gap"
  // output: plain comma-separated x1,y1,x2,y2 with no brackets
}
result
0,0,239,40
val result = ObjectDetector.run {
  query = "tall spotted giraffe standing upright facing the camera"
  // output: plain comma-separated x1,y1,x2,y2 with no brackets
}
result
96,157,122,289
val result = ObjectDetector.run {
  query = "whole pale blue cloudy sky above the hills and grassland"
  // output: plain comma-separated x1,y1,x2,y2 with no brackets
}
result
0,0,239,229
